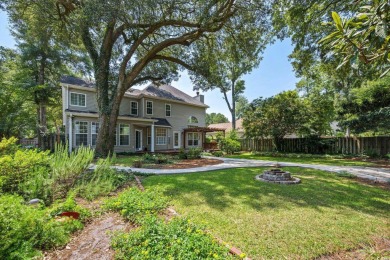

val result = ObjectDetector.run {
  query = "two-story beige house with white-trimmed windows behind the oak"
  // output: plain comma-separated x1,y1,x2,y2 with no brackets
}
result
61,76,208,152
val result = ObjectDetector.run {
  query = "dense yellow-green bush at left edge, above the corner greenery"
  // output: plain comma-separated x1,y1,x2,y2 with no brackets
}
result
0,147,50,199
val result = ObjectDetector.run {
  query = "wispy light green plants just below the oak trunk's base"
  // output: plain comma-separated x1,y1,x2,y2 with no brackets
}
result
75,157,133,200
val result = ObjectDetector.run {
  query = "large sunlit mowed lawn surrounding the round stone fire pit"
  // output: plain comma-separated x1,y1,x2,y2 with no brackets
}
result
144,167,390,259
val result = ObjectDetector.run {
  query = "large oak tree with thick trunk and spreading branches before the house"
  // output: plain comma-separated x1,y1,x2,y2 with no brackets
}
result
3,0,272,155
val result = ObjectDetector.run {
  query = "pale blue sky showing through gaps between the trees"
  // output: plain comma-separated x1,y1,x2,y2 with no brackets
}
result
0,11,298,120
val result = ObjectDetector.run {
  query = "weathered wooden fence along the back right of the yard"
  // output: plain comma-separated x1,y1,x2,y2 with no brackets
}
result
240,136,390,156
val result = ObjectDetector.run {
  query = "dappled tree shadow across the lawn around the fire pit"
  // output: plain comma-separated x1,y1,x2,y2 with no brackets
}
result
144,167,390,217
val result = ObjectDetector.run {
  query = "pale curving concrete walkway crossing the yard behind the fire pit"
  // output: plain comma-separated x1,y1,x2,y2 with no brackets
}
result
109,156,390,183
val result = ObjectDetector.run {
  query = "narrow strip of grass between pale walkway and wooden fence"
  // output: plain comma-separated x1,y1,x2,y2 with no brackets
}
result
226,152,375,166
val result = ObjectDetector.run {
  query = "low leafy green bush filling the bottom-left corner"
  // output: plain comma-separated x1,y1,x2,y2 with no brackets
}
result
0,195,83,259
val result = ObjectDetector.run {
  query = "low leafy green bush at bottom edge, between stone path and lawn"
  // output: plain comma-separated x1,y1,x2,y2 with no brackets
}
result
111,218,233,259
